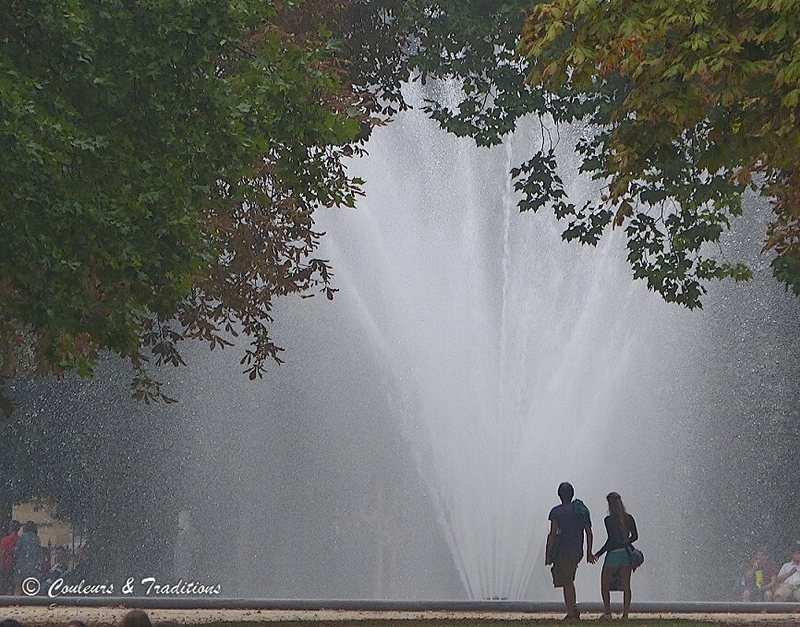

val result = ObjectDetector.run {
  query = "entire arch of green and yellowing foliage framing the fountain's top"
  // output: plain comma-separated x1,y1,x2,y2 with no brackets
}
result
0,0,800,412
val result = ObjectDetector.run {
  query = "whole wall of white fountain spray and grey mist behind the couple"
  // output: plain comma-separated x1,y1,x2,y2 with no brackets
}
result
6,102,800,601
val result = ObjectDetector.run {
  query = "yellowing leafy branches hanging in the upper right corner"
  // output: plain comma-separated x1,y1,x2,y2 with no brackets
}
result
519,0,800,307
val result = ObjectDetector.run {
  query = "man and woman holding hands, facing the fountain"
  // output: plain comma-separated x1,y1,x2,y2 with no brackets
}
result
544,482,639,620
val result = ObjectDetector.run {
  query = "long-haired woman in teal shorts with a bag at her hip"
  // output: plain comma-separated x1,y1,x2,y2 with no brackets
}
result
594,492,639,619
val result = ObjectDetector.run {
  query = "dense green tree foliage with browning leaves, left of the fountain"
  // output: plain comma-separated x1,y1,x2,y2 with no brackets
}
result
0,0,368,412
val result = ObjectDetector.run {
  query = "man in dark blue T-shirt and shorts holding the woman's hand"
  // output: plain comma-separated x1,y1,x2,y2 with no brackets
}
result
544,482,595,621
